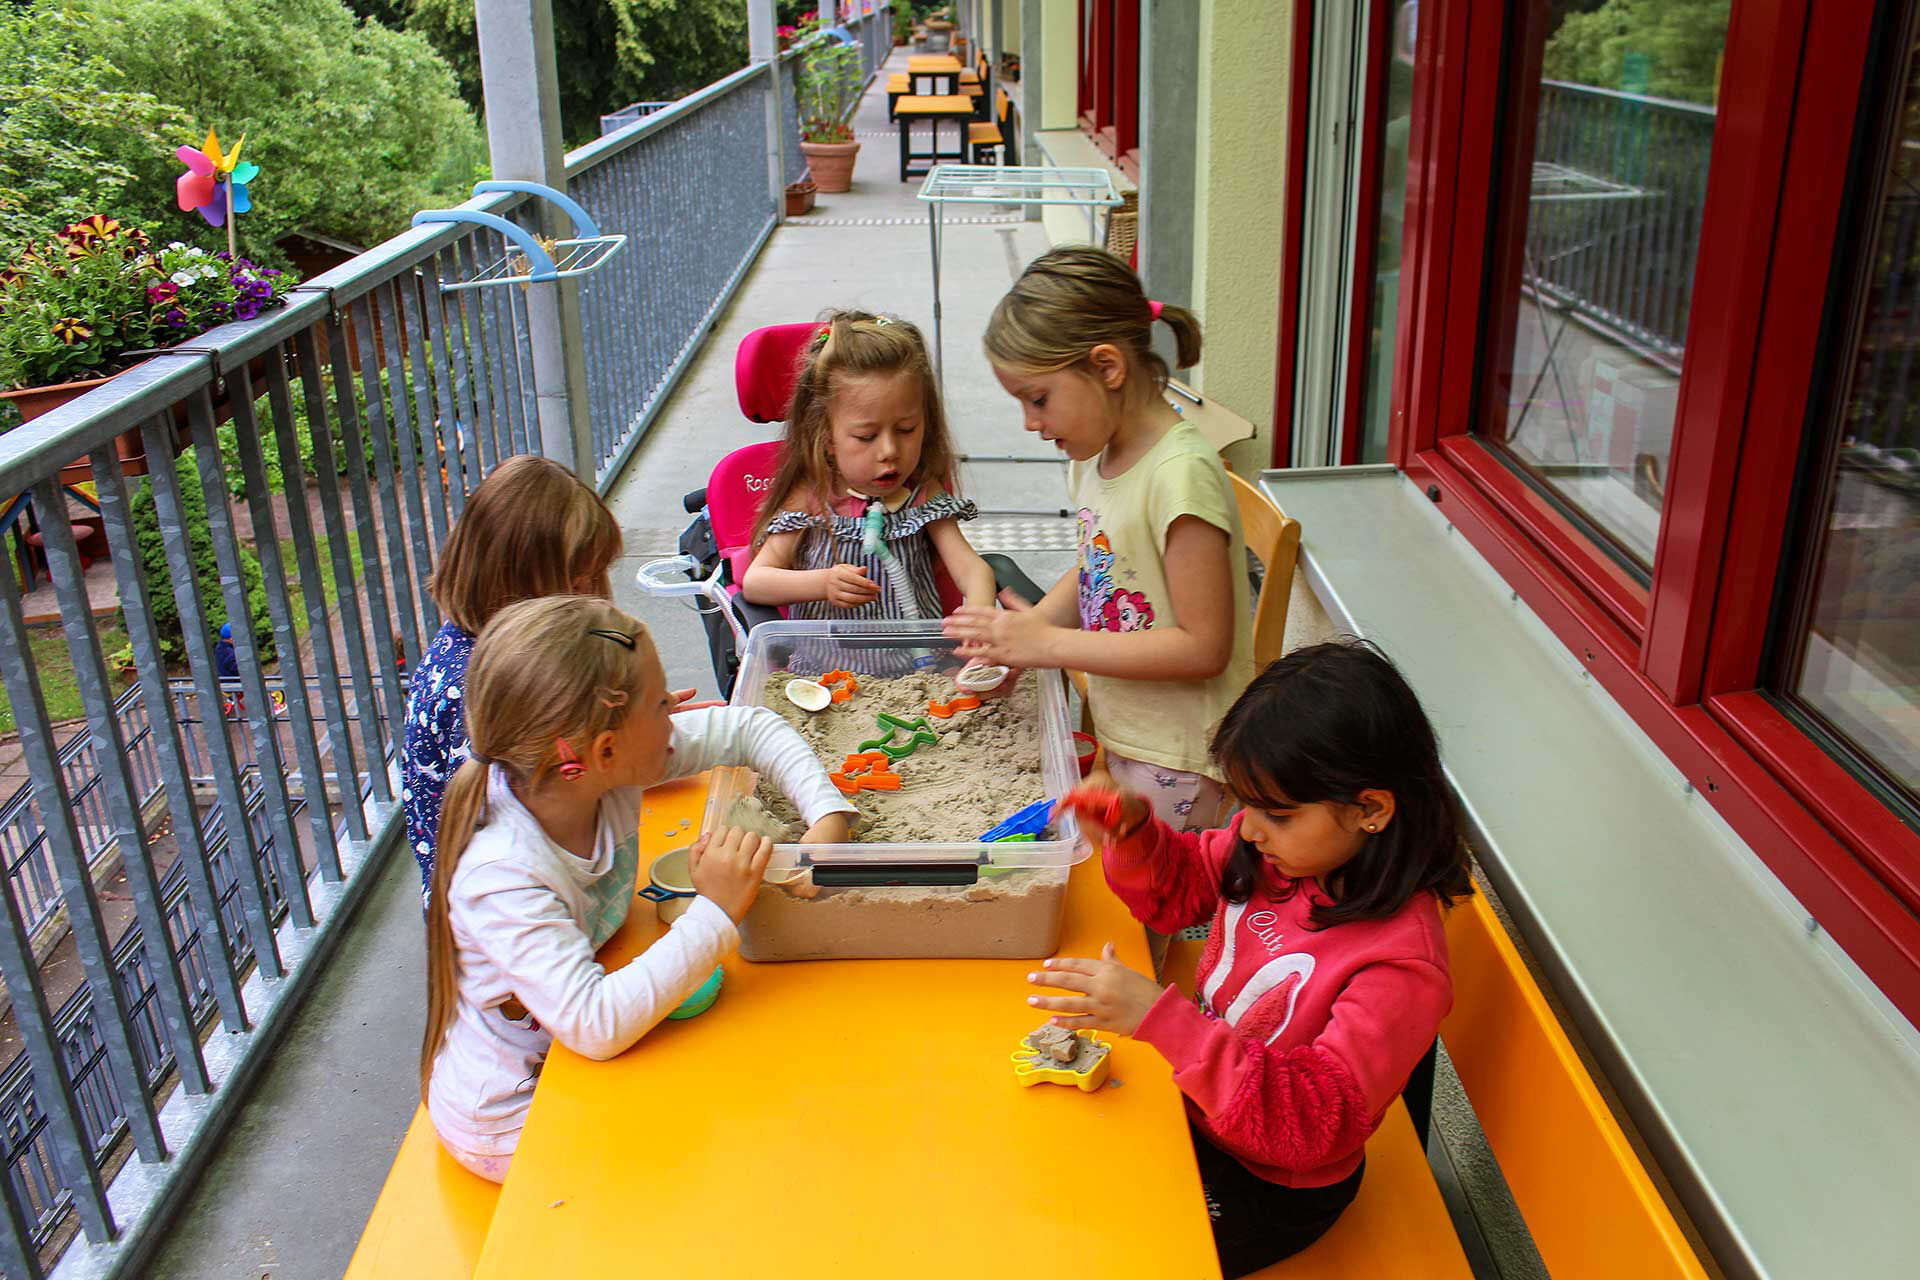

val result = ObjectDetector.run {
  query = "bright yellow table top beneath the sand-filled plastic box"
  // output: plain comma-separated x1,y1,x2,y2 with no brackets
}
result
474,779,1219,1280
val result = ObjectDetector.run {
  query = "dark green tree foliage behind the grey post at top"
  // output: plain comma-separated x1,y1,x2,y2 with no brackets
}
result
407,0,747,146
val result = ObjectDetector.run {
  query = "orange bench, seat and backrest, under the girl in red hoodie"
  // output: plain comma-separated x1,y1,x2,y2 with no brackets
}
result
1165,890,1707,1280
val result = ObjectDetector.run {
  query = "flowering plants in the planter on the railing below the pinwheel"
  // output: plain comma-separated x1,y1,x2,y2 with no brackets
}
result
0,215,296,480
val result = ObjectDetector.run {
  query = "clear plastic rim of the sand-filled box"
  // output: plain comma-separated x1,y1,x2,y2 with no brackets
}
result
701,620,1091,869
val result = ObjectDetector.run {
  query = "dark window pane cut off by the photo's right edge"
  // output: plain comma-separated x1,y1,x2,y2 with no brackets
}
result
1788,37,1920,798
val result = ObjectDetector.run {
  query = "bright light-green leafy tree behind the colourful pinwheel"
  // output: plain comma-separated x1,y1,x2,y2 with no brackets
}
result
71,0,484,249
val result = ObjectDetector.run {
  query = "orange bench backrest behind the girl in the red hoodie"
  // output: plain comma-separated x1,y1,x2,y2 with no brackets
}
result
1440,890,1707,1280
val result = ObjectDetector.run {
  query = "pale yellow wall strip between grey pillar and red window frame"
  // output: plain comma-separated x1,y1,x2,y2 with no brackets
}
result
1190,0,1296,474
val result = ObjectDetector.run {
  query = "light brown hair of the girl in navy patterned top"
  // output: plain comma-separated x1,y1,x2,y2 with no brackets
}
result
428,453,620,635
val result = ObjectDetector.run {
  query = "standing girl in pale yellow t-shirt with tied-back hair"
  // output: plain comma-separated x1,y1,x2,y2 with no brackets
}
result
947,248,1254,831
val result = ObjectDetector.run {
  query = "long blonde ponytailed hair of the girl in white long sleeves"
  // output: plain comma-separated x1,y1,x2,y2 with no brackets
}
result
420,595,666,1102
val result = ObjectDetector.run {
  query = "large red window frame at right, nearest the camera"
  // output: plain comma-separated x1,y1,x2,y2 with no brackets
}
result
1388,0,1920,1023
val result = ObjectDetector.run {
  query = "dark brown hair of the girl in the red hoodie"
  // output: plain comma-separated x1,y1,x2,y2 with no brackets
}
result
1213,641,1473,929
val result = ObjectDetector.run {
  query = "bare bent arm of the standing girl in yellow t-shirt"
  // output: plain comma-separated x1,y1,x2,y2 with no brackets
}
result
947,516,1235,679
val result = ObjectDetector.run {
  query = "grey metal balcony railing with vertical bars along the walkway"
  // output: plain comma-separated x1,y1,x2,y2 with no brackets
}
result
0,6,891,1280
